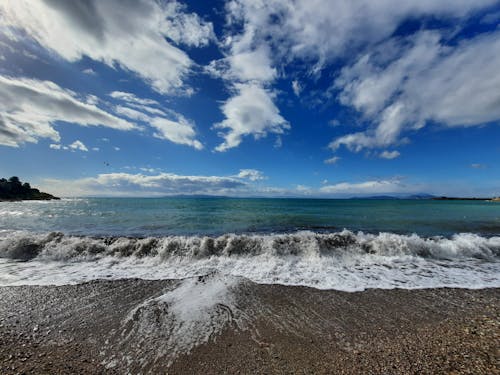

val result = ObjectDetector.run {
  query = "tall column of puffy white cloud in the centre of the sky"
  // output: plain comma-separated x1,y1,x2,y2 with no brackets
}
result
208,2,290,152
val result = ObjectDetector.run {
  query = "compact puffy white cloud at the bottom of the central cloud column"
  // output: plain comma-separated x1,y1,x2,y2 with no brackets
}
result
213,84,290,151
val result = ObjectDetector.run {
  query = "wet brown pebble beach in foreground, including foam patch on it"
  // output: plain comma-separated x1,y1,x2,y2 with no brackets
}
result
0,278,500,374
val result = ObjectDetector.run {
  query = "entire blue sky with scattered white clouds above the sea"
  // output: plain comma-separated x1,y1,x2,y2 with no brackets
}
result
0,0,500,198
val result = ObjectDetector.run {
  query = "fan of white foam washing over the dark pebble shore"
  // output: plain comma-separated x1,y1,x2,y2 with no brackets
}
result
104,274,239,366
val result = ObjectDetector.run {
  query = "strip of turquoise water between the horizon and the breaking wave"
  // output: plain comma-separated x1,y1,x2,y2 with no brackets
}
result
0,198,500,236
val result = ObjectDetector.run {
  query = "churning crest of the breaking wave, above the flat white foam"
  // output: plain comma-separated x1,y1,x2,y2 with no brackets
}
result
0,230,500,260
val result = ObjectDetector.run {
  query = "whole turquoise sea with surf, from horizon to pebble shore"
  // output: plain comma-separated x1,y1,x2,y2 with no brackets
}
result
0,197,500,291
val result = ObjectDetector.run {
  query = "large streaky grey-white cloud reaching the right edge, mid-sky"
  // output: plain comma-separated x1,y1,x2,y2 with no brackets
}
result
330,31,500,152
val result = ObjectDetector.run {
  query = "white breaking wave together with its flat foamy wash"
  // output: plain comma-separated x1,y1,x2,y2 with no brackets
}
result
0,230,500,291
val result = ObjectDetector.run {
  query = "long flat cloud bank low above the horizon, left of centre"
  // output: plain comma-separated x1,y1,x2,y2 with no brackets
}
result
41,173,252,196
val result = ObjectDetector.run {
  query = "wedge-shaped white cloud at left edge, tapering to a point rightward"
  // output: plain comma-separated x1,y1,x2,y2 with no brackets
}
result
0,76,138,147
